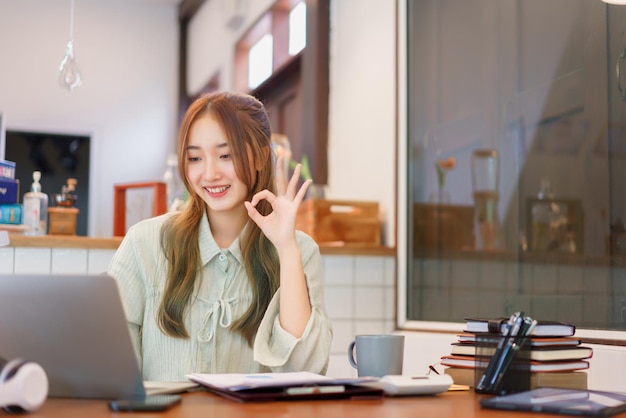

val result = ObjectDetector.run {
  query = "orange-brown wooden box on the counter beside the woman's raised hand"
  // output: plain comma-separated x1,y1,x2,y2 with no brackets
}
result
296,198,381,246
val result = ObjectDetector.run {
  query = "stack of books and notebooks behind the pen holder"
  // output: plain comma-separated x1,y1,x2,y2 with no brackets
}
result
441,318,593,389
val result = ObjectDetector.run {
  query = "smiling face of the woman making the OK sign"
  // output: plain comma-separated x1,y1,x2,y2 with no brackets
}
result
185,114,248,218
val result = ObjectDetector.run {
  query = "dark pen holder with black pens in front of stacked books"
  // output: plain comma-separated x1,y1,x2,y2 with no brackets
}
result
474,334,530,395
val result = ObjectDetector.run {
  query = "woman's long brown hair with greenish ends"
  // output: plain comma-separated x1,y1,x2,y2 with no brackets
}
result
157,92,280,346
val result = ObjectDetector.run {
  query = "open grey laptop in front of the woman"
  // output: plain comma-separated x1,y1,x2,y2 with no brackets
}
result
0,274,194,399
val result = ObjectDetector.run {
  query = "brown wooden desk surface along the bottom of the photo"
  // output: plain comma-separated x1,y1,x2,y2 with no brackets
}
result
13,390,626,418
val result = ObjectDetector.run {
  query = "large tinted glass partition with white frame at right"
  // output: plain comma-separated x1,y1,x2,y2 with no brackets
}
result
398,0,626,330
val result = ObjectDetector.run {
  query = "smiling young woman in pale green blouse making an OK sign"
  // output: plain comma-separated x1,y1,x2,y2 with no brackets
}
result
108,92,332,381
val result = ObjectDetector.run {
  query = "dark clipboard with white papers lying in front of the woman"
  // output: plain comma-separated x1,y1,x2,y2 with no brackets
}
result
187,372,384,402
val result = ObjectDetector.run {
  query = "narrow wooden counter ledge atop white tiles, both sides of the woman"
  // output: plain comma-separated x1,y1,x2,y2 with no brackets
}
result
4,234,396,256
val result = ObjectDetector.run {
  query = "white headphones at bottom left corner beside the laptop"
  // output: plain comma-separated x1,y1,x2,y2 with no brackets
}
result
0,358,48,412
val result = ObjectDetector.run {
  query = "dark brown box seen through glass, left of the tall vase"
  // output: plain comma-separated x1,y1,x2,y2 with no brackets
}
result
413,203,475,249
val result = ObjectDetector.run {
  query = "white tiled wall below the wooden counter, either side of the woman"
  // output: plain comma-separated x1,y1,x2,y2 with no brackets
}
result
0,247,396,377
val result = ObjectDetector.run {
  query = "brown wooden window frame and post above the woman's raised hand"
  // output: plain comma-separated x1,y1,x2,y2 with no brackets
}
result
234,0,330,184
